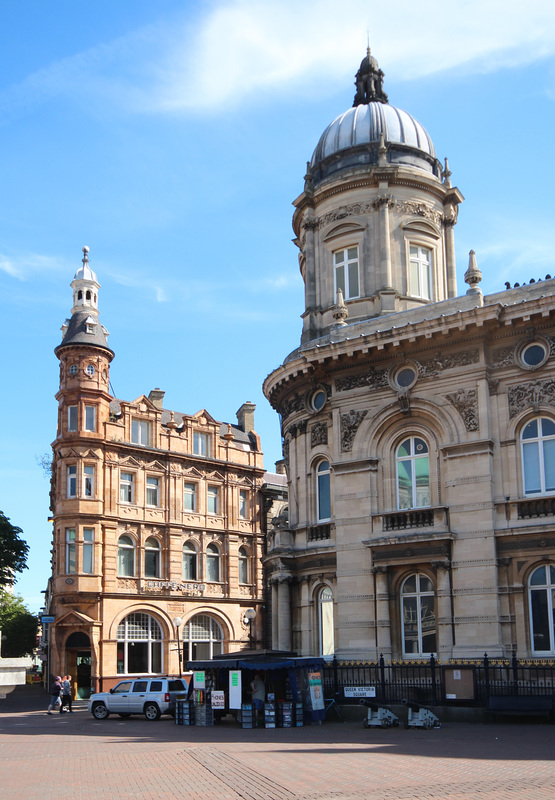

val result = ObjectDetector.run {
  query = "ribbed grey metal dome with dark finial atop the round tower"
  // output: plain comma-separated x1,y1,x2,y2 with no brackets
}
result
309,48,441,185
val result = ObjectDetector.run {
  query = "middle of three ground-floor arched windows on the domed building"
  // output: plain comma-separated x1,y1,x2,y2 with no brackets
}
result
401,574,437,656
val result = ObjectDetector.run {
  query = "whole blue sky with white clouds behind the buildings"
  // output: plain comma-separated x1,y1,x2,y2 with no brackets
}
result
0,0,555,610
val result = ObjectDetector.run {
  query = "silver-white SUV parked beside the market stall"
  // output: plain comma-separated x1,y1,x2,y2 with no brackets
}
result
88,677,189,721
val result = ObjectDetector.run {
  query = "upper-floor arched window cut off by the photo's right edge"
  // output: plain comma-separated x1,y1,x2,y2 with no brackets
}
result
520,417,555,495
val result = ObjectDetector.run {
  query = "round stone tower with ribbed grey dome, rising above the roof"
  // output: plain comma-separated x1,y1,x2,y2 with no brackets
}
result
293,48,463,344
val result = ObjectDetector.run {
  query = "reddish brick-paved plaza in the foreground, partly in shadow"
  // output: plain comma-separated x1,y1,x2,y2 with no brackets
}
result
0,689,555,800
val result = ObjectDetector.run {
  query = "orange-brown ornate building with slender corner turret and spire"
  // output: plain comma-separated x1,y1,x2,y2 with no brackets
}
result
47,248,270,696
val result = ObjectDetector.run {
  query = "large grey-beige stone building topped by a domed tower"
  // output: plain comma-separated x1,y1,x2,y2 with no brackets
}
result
264,51,555,659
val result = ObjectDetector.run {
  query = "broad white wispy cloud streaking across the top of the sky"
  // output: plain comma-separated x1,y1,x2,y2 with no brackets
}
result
0,0,555,119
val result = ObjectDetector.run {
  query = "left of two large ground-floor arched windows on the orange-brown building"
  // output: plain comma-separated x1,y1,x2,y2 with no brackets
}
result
117,612,162,675
